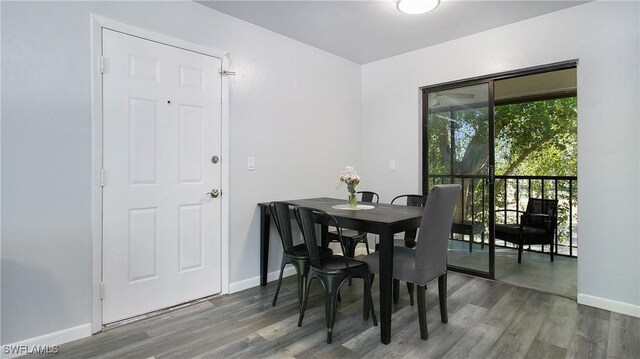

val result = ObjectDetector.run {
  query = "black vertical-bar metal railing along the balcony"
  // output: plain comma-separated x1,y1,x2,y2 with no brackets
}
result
427,175,578,257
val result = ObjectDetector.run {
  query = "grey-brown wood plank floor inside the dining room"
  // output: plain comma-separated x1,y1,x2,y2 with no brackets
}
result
36,272,640,359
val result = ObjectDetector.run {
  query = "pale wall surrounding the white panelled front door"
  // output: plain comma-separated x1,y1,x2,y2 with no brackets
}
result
0,1,361,344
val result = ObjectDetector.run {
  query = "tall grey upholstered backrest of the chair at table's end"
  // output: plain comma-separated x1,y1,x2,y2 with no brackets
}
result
416,184,461,284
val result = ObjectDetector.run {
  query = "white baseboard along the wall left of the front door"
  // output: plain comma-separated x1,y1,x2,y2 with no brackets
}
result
2,323,91,359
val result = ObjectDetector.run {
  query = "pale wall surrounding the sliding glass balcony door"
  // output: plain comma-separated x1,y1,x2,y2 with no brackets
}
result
362,2,640,315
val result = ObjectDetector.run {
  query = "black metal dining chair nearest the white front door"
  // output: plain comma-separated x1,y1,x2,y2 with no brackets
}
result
269,202,333,307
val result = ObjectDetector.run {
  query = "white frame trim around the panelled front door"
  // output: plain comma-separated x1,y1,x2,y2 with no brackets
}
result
90,14,230,334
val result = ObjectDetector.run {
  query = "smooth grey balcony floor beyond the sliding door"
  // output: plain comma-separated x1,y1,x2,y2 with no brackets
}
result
449,241,578,298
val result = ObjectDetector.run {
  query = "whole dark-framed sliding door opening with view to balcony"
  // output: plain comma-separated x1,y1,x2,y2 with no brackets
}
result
423,61,578,298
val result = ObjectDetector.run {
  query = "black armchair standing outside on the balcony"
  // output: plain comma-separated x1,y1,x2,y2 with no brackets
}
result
495,198,558,263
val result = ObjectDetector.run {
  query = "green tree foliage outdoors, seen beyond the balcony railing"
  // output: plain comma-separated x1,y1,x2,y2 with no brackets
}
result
427,97,578,252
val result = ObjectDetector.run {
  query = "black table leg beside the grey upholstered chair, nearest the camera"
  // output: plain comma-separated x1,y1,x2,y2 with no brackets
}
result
380,229,393,344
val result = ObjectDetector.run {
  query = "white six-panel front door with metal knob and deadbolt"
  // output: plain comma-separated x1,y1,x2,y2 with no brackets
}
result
102,29,221,324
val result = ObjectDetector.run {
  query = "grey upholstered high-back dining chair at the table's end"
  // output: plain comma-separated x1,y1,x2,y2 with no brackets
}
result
363,184,461,340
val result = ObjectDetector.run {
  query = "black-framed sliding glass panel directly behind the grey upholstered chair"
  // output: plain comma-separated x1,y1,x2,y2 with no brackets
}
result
423,81,494,278
